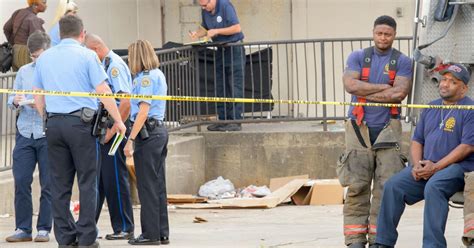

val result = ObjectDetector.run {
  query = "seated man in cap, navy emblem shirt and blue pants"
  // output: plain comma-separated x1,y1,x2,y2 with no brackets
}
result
376,64,474,247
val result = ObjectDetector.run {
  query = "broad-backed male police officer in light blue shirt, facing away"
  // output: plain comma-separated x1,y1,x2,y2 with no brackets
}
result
33,15,126,247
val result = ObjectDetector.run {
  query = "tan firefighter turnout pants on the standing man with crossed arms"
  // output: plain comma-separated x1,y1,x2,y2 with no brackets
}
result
336,119,406,245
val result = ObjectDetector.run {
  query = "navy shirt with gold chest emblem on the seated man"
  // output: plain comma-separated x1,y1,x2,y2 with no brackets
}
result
412,97,474,172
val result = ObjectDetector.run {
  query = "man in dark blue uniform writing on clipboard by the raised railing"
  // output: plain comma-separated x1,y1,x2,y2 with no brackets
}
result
191,0,245,131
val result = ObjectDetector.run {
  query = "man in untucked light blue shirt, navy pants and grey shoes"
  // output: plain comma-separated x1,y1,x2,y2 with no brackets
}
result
6,31,53,242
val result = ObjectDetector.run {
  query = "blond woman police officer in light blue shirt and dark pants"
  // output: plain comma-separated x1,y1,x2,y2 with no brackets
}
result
125,40,169,245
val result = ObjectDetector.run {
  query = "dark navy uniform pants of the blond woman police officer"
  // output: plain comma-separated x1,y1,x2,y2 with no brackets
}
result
133,126,169,240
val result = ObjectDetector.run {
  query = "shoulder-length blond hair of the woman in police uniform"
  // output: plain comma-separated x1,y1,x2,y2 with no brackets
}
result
128,40,160,75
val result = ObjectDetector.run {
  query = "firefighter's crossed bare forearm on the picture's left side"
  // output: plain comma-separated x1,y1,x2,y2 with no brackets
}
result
342,70,392,97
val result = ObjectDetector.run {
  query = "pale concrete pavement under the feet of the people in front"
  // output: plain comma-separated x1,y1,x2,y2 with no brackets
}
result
0,203,463,248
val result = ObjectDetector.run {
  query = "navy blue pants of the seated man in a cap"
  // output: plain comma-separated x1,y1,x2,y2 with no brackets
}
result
375,164,464,248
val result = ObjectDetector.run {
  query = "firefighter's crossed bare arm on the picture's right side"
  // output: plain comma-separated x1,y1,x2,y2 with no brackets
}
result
365,76,412,103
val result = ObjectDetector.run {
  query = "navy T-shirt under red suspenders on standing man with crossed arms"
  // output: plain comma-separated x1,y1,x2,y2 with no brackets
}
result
346,49,413,127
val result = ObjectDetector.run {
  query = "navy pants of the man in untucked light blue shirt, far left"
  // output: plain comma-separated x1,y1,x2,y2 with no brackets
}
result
12,133,53,233
